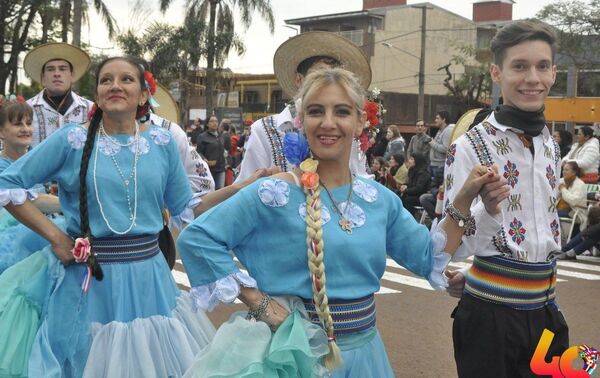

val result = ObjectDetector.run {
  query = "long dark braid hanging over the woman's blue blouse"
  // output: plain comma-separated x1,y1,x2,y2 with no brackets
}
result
79,108,104,281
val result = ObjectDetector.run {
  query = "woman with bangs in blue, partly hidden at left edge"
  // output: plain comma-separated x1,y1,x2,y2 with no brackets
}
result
0,101,64,273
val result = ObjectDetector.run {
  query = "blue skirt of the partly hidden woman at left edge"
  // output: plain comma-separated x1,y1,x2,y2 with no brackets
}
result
0,214,66,274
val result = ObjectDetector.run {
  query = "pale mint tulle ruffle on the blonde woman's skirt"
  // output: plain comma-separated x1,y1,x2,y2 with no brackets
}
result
184,297,328,378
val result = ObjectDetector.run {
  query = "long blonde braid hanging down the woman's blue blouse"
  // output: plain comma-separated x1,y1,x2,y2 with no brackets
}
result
304,186,342,370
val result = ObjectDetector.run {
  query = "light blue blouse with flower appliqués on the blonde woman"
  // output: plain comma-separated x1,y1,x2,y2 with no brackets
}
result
177,178,436,301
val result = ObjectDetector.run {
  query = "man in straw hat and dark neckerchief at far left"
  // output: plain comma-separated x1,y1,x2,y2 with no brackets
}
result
23,43,92,147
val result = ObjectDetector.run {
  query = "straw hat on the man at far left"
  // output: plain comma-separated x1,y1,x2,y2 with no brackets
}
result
23,42,91,83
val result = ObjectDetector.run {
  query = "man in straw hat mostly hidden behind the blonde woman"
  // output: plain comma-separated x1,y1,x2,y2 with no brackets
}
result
236,31,371,182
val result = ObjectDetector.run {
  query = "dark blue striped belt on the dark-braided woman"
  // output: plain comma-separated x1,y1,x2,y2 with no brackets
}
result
92,235,160,264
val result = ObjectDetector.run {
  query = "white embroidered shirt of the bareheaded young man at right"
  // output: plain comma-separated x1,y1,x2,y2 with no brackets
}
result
444,114,560,262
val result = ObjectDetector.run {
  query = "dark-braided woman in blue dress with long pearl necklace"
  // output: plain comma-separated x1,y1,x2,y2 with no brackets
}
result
0,58,214,377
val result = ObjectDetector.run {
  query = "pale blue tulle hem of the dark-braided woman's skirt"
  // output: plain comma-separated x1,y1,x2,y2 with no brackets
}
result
83,294,215,378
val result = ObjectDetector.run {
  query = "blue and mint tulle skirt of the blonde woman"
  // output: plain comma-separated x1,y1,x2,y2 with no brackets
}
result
185,297,394,378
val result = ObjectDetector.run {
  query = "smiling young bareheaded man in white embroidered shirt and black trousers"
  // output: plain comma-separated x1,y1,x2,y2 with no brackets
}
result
445,21,569,378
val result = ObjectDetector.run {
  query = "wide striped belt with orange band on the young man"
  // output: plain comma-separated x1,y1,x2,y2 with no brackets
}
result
465,256,556,310
